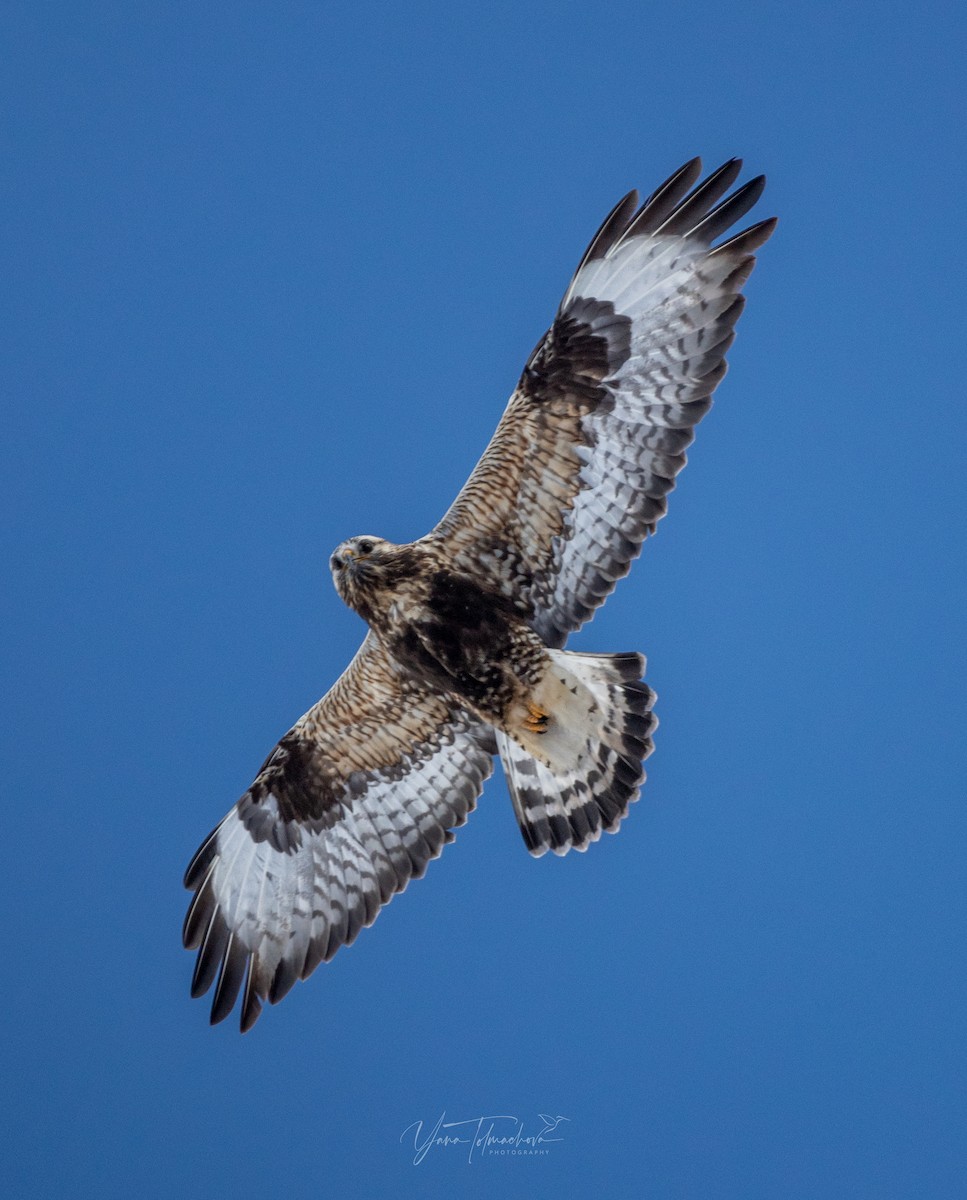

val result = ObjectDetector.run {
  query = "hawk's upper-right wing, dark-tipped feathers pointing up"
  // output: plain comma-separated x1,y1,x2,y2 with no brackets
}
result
428,158,775,646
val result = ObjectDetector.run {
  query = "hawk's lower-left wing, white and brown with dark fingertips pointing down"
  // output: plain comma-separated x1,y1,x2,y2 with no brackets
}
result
184,634,495,1032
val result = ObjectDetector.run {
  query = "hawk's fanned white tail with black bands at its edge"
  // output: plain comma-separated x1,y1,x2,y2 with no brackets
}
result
497,650,657,856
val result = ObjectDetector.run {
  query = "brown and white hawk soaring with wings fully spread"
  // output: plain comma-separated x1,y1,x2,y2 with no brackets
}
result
184,158,776,1032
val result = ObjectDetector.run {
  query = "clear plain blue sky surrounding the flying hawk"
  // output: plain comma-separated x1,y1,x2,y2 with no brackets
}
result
0,0,967,1200
